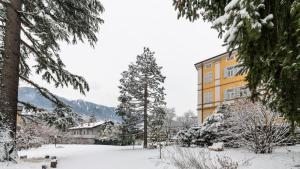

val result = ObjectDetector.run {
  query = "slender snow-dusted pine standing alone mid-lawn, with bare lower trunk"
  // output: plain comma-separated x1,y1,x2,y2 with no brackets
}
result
119,48,165,148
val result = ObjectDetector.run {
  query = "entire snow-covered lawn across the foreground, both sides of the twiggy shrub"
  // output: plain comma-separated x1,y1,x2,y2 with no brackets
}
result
0,145,300,169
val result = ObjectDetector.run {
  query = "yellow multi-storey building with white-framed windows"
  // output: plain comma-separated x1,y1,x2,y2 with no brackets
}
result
195,52,250,124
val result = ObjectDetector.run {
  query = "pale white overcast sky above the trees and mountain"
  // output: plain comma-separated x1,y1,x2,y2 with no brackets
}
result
22,0,225,115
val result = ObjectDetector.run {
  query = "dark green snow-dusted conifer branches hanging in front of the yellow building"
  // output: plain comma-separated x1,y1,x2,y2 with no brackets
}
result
173,0,300,129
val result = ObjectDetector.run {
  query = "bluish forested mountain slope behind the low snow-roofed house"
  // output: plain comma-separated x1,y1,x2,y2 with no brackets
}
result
18,87,120,121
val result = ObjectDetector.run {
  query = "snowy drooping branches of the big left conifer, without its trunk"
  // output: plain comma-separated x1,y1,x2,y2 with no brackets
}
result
0,0,104,129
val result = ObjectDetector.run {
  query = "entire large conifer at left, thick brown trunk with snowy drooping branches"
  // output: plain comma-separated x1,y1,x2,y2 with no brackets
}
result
0,0,104,160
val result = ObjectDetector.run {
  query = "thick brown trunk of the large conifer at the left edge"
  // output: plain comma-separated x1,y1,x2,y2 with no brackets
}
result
0,0,22,160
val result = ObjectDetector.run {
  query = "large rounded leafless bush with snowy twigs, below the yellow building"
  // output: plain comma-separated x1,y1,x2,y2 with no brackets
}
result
229,99,290,153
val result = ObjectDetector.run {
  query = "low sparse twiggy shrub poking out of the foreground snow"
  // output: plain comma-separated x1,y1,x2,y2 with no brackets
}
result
168,147,238,169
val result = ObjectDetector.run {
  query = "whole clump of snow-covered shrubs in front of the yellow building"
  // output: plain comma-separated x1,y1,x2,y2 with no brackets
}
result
177,99,291,153
